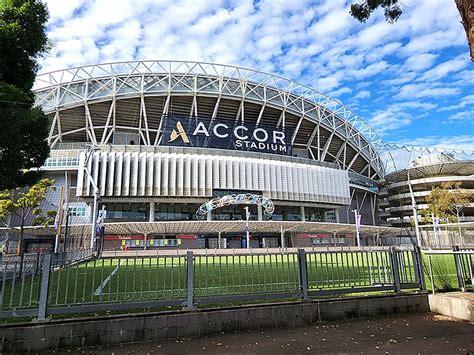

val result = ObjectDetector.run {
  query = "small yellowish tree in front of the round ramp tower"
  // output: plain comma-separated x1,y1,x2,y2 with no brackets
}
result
423,181,472,222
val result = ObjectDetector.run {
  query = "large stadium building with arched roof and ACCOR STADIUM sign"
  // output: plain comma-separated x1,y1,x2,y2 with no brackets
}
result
12,61,396,250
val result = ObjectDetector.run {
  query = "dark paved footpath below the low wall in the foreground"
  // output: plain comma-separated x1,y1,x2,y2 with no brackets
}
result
56,314,474,355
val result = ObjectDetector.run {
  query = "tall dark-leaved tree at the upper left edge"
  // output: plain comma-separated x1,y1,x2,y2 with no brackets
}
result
0,0,49,191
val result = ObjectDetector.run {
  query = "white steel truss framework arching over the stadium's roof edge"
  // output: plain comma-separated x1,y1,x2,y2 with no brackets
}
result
34,61,387,181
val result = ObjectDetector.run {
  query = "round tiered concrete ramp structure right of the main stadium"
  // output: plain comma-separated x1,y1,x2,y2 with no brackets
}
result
379,153,474,227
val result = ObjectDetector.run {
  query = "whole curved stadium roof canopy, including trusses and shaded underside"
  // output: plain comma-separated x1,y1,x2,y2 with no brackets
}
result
34,61,386,178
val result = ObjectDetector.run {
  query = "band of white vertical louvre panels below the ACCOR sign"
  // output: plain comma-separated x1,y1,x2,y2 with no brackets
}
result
78,152,350,204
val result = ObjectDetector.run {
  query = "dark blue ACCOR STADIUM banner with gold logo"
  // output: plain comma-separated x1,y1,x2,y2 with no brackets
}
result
161,116,293,155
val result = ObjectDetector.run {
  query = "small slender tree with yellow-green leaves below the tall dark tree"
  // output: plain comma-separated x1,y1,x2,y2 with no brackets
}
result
0,179,54,255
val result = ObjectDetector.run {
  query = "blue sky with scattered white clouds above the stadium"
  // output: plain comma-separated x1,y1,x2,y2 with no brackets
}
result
40,0,474,150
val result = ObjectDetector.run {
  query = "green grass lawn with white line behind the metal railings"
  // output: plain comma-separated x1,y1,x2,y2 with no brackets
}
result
0,251,466,318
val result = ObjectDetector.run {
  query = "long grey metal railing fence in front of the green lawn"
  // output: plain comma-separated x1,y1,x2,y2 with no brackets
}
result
0,247,425,319
